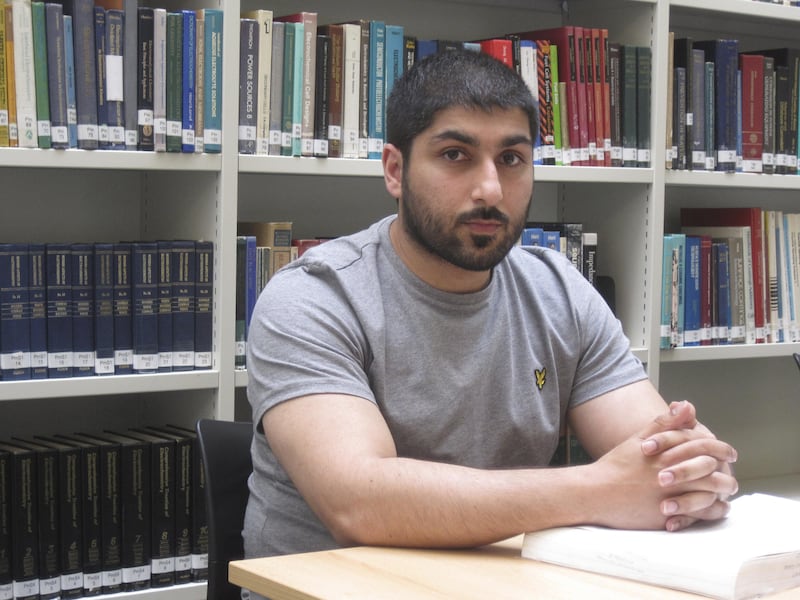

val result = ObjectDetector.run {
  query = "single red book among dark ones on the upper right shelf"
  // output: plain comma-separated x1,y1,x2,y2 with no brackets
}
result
739,54,764,173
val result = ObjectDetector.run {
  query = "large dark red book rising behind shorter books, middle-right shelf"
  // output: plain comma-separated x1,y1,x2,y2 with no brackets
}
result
681,208,769,344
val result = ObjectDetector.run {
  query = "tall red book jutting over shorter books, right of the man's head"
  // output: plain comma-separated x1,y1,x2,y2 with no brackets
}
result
515,25,589,166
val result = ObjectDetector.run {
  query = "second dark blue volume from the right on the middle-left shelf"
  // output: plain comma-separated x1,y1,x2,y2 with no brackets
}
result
171,240,197,371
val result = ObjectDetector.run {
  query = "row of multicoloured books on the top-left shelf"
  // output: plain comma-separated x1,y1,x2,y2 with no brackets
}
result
0,0,223,153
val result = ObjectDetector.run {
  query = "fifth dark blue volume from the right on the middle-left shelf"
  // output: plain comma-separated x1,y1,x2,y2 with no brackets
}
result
112,242,133,375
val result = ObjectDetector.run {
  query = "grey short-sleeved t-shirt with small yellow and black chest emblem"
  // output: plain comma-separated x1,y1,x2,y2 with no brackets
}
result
243,217,646,557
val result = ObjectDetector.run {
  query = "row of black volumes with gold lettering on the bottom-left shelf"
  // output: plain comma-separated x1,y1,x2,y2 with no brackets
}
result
0,425,208,600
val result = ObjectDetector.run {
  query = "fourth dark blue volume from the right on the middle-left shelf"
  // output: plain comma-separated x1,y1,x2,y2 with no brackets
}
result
131,242,158,373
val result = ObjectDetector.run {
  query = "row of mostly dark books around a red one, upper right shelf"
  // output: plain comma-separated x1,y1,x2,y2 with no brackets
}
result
666,34,800,175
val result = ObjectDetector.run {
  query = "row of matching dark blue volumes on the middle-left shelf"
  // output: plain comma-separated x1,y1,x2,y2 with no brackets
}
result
0,240,214,381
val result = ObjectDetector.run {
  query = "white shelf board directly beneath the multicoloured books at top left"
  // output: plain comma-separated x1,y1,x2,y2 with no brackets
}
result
0,148,222,172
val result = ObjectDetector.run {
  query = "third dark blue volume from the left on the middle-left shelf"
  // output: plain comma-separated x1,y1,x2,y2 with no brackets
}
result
45,242,73,379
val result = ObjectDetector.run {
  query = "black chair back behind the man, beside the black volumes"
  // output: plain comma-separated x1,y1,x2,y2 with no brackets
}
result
197,419,253,600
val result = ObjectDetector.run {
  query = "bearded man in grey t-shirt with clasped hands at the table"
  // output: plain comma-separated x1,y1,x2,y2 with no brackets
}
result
244,51,737,568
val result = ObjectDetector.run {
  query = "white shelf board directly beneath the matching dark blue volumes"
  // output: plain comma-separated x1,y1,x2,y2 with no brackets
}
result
0,371,219,401
